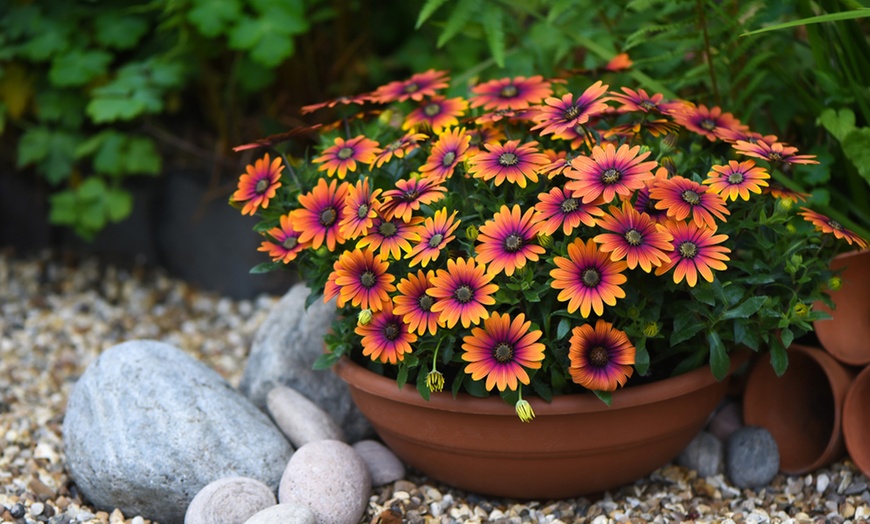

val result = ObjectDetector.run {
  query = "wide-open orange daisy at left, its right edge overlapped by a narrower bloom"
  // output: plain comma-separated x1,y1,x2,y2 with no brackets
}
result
290,178,350,251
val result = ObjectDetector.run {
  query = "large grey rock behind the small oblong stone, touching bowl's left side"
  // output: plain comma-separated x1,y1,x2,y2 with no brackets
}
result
239,284,374,442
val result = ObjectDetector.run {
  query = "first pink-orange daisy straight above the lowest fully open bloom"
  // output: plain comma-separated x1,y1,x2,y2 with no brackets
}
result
475,204,545,276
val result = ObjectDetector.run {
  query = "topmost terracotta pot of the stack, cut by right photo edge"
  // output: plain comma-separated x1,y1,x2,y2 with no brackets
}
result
813,251,870,366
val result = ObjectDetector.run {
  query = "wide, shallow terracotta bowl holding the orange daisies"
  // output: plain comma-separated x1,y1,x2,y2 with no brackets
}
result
334,353,746,499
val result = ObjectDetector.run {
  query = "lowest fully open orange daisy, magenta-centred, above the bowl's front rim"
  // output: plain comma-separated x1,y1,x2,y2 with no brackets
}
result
462,313,544,391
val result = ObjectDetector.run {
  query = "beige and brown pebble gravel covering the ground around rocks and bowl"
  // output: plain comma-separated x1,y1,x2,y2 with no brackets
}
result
0,251,870,524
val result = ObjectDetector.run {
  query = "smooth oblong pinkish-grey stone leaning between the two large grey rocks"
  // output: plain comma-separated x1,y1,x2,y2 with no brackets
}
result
266,386,345,448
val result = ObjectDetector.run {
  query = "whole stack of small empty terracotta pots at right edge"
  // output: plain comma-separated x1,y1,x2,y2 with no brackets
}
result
743,251,870,476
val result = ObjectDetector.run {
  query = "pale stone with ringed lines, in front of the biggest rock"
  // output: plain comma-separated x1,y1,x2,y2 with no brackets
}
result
184,477,278,524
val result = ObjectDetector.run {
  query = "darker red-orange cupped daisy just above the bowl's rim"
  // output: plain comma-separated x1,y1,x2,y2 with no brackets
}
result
568,319,637,391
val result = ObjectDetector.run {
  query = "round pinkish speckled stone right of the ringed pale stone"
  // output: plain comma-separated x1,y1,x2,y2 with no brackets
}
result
278,440,372,524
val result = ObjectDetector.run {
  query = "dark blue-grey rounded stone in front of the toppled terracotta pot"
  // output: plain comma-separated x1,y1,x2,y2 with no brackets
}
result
725,426,779,489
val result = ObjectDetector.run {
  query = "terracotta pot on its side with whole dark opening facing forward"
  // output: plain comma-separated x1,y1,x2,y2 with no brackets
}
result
743,344,853,475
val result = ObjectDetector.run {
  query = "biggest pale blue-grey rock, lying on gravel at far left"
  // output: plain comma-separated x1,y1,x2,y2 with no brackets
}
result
63,340,293,524
